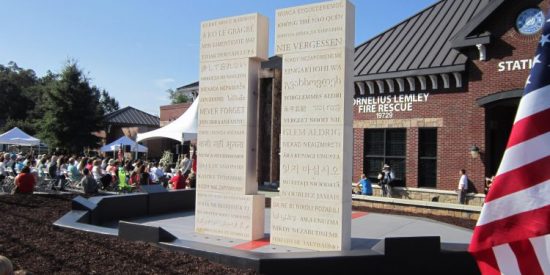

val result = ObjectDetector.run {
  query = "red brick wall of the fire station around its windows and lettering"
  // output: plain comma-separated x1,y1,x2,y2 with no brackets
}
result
353,0,549,192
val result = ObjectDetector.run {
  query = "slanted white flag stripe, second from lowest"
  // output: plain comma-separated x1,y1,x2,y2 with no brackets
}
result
497,132,550,175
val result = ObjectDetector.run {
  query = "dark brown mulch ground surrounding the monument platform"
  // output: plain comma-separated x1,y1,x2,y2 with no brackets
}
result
0,195,475,275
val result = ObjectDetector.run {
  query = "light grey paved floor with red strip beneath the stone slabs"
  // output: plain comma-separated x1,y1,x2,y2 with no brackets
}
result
132,209,472,254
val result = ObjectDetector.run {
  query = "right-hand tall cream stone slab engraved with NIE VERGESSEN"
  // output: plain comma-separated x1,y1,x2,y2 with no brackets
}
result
271,1,355,251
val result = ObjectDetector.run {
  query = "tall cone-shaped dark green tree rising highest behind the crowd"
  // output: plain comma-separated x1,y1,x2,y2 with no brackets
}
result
39,61,104,153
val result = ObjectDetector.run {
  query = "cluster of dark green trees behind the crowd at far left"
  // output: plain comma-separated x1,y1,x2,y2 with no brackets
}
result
0,61,119,153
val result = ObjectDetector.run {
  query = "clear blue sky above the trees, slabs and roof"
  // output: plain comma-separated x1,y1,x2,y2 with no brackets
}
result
0,0,437,115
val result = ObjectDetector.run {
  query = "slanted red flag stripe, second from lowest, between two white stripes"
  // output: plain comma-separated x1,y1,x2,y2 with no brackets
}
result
485,155,550,202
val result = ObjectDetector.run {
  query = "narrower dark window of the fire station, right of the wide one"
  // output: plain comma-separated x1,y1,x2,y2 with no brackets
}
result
418,128,437,188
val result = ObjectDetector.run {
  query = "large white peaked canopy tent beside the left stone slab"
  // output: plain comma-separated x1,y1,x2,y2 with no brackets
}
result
137,97,199,142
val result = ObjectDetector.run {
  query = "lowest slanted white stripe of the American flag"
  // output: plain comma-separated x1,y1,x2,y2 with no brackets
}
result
477,180,550,226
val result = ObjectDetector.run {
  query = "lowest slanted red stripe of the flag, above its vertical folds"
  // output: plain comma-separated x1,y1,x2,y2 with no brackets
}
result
469,205,550,252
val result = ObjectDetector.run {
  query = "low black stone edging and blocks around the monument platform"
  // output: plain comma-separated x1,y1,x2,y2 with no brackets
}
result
54,192,479,274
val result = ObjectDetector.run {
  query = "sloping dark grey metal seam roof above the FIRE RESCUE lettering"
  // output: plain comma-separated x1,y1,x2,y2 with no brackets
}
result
354,0,495,81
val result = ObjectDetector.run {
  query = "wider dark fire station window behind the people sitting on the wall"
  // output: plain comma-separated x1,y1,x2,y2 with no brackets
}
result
363,129,407,186
